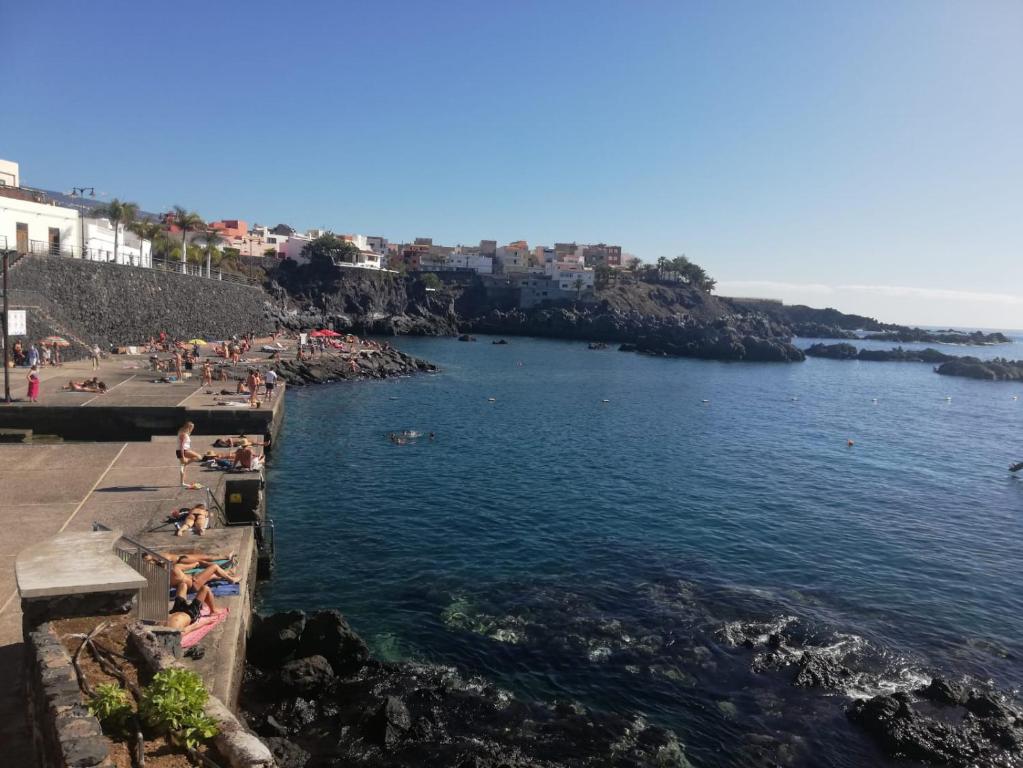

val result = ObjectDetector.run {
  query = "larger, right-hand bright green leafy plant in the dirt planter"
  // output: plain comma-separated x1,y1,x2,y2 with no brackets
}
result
139,668,217,750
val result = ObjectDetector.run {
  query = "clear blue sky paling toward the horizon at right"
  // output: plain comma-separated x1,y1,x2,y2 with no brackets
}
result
0,0,1023,327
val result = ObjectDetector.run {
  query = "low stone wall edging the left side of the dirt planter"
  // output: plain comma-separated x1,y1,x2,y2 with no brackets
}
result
25,622,113,768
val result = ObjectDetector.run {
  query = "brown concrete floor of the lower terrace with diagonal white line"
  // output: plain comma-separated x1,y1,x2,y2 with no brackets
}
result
0,437,251,766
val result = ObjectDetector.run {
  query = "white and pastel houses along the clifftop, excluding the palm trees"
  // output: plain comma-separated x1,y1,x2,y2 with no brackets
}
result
0,160,637,306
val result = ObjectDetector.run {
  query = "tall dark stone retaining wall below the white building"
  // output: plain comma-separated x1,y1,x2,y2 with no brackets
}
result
10,256,273,348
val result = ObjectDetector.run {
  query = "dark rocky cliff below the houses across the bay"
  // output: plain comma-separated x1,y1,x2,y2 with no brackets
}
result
270,267,803,362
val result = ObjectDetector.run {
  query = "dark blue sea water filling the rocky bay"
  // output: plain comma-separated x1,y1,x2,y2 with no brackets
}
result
260,336,1023,766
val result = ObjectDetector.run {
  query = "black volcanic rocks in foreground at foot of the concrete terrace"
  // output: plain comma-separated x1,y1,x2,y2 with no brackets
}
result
240,611,688,768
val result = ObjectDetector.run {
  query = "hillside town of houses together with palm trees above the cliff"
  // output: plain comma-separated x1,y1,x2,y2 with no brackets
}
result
0,160,639,306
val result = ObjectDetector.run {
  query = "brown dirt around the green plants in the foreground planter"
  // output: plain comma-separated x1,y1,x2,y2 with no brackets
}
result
53,616,226,768
